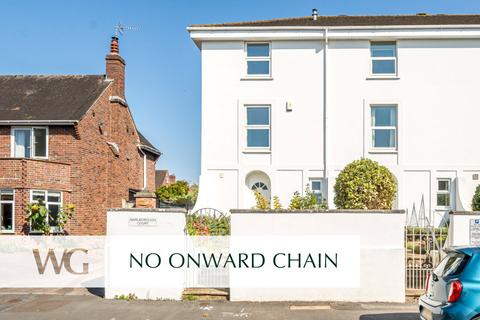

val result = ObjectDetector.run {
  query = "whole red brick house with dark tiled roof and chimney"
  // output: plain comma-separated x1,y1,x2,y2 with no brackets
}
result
0,37,161,235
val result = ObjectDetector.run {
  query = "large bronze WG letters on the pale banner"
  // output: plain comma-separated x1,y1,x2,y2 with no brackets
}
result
32,248,88,275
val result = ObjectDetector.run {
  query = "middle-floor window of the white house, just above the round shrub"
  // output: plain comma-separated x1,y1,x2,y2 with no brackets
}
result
371,105,397,149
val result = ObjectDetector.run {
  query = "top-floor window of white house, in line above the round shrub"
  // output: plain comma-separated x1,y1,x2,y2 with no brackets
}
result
370,42,397,75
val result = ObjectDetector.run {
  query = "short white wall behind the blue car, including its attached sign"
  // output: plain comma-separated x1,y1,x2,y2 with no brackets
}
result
448,211,480,246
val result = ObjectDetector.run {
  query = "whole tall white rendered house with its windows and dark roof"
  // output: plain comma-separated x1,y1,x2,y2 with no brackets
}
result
188,11,480,224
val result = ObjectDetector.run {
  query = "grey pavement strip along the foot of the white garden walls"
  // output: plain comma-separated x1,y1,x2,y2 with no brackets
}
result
0,289,419,320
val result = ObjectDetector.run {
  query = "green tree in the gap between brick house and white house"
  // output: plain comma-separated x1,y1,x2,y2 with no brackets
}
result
156,180,198,208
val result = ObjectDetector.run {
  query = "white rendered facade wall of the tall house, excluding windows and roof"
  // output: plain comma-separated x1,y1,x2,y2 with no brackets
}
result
191,28,480,224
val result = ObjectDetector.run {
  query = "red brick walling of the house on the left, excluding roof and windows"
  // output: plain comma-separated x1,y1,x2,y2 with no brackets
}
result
0,80,159,235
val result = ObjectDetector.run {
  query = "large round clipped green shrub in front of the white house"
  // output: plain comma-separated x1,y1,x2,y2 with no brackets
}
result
334,158,397,209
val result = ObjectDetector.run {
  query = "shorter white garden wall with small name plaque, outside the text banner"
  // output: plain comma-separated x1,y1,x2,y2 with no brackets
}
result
105,208,186,300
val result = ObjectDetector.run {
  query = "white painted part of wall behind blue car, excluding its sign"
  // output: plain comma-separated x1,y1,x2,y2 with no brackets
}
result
448,212,480,246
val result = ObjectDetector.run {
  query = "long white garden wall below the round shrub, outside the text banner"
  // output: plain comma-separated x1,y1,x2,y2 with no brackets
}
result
230,211,405,302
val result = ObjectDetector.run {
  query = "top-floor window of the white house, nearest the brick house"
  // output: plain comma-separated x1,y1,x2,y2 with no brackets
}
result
246,42,271,77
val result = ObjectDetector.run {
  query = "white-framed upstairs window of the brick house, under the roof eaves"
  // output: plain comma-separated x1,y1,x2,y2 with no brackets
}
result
12,127,48,158
